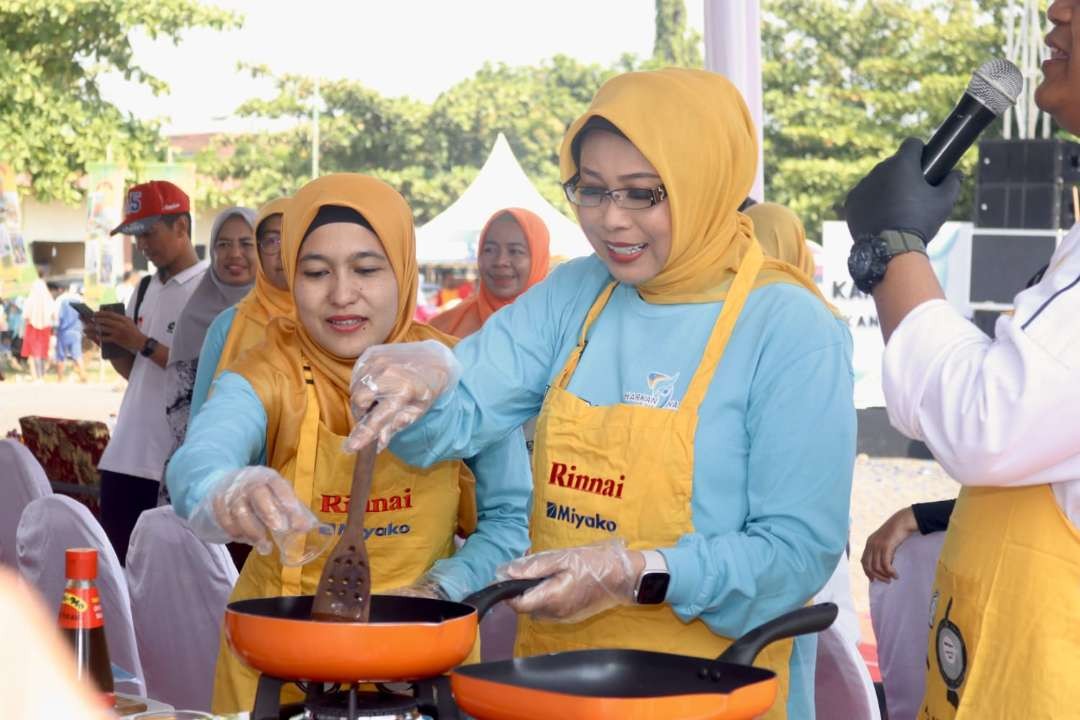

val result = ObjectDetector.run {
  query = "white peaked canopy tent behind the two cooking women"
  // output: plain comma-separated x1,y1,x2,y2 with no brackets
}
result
416,133,593,264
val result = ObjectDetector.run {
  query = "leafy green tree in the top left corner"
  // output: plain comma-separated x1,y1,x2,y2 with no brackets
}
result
0,0,238,203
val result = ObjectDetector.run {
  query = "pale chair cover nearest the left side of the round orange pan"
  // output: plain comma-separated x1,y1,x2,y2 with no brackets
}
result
126,505,238,710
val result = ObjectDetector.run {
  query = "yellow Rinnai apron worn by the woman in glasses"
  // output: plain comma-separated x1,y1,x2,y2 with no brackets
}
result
515,243,792,718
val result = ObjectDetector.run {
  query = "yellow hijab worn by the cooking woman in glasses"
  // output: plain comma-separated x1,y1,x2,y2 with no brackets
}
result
559,68,825,304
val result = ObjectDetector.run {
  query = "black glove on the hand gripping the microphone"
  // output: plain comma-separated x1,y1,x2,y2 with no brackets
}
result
843,137,961,243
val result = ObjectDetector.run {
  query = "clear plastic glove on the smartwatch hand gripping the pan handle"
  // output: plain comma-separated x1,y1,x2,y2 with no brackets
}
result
498,539,645,623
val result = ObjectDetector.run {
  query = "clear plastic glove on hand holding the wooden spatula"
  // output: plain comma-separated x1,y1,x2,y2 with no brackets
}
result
345,340,461,452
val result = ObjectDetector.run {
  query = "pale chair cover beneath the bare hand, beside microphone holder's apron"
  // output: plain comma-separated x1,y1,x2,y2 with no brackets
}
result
870,532,945,720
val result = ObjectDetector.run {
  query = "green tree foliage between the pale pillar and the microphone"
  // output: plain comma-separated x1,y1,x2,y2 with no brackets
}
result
761,0,1007,241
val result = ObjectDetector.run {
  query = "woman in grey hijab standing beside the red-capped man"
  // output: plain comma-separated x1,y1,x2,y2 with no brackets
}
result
165,207,258,449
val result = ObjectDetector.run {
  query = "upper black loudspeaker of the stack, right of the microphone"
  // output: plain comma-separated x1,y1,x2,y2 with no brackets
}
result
974,139,1080,230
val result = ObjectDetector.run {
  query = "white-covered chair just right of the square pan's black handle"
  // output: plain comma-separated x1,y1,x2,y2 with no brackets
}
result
813,554,881,720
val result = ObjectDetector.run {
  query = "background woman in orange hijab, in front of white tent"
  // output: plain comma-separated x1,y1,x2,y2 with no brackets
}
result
431,207,549,338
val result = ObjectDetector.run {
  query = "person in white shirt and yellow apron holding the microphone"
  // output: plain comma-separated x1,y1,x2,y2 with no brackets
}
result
845,0,1080,720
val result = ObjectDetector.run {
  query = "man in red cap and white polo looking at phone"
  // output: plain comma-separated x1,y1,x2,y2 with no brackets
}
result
88,180,207,562
